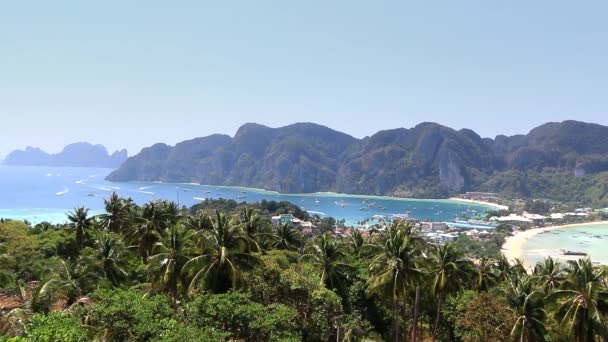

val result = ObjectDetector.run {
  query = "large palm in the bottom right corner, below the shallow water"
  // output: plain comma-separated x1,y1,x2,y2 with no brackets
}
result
552,258,608,342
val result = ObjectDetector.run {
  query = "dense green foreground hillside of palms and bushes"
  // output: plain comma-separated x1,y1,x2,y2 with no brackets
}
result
0,196,608,342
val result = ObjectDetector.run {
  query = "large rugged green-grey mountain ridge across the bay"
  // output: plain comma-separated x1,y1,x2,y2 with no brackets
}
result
108,121,608,204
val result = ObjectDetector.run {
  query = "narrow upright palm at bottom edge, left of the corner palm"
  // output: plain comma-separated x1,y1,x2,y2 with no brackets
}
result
506,274,547,342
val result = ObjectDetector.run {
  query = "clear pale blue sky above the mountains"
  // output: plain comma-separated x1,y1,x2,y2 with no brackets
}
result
0,0,608,156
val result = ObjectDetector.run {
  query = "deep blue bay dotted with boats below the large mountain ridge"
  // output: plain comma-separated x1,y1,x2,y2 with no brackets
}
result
0,166,490,224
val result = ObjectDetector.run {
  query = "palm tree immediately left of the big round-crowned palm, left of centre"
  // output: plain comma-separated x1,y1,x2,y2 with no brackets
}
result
148,224,196,308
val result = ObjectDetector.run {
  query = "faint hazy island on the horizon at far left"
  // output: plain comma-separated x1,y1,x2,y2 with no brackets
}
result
2,142,128,168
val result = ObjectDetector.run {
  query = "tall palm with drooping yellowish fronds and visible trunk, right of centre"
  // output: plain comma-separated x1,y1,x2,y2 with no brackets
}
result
367,220,423,341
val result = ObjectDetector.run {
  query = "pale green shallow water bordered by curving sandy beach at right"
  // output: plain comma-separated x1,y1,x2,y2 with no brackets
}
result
523,224,608,265
